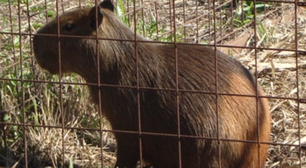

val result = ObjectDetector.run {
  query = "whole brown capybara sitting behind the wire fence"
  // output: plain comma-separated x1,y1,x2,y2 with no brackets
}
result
33,0,270,168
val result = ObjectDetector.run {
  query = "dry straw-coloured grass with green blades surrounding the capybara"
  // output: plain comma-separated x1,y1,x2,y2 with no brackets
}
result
0,0,306,168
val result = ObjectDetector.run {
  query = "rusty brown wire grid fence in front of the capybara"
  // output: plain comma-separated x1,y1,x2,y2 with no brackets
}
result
0,0,306,167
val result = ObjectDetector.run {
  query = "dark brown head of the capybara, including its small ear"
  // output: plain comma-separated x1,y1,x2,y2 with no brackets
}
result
33,0,114,75
